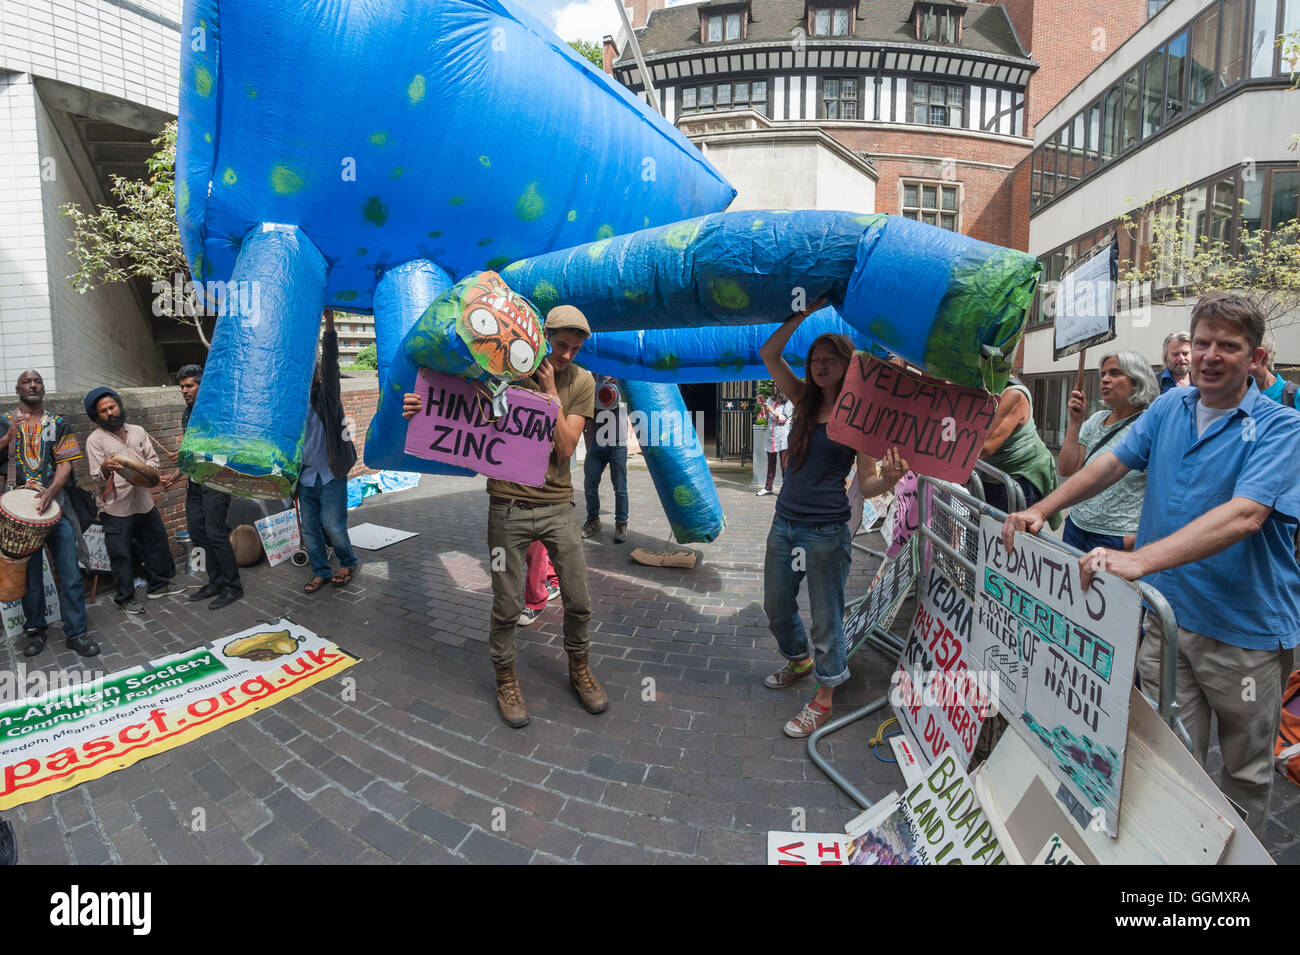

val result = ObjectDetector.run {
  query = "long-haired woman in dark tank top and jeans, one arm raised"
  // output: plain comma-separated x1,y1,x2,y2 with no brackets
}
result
759,300,907,739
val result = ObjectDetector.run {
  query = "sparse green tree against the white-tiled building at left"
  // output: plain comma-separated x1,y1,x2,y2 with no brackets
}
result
60,122,209,348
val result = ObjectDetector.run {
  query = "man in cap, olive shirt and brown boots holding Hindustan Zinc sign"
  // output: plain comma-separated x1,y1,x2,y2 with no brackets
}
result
403,305,607,729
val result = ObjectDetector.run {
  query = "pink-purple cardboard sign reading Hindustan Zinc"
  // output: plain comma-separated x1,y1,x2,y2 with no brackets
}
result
406,368,559,487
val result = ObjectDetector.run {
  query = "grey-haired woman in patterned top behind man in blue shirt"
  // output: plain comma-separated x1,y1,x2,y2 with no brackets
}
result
1061,352,1160,552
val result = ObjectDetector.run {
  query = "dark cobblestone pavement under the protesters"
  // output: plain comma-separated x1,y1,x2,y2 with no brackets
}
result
0,468,1300,864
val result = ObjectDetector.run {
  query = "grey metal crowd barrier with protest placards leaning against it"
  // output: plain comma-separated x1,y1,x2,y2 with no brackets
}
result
809,461,1192,809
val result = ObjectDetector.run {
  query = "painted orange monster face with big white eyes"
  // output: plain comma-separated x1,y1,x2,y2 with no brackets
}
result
456,272,546,379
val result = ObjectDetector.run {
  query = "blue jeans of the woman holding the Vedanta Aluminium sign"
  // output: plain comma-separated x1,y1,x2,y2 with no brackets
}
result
763,517,853,689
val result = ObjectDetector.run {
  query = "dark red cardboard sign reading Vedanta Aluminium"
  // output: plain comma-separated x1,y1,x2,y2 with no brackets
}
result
826,352,997,485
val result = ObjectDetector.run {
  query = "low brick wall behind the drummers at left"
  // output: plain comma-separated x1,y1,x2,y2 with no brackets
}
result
0,373,380,557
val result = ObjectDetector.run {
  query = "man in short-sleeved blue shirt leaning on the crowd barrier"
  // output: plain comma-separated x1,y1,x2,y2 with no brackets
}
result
1002,292,1300,834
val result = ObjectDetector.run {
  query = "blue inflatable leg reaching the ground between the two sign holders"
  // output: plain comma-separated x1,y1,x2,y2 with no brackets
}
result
623,381,727,544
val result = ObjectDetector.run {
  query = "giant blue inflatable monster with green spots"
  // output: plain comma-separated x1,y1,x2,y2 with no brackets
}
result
177,0,1037,539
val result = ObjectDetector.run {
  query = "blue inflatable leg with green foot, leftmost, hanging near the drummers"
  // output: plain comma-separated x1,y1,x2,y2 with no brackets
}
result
179,222,328,498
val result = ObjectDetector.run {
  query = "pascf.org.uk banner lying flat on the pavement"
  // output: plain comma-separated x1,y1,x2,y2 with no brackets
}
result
0,620,358,811
